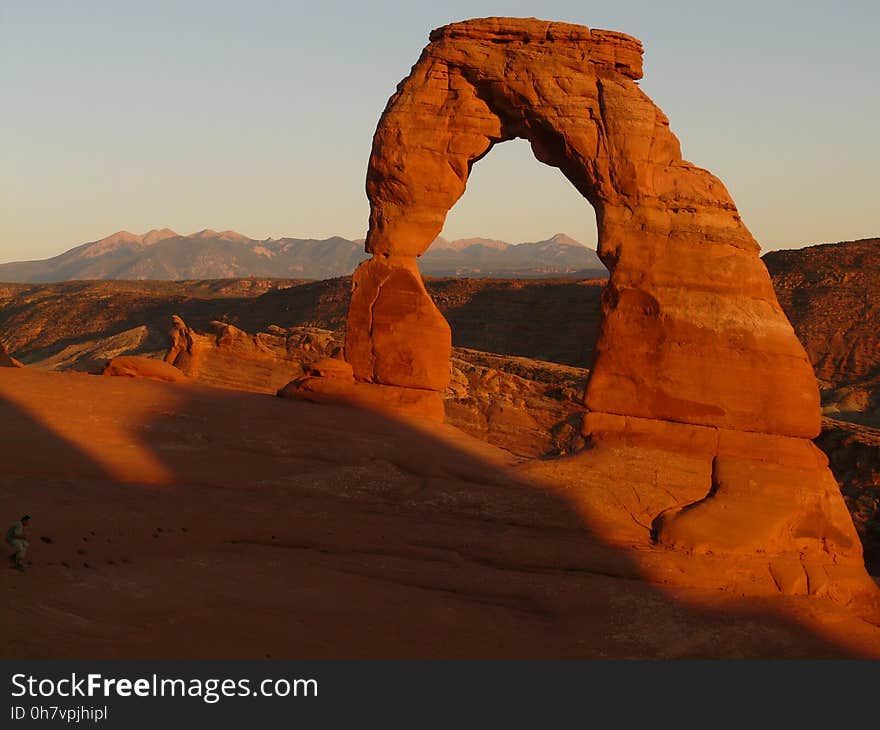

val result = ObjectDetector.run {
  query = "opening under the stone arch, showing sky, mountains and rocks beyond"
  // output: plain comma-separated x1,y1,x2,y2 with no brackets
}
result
432,137,608,459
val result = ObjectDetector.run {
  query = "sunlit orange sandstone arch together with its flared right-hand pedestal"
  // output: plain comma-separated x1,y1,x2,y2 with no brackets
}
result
288,18,873,600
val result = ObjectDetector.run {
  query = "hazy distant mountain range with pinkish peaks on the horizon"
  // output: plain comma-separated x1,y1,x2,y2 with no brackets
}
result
0,228,607,283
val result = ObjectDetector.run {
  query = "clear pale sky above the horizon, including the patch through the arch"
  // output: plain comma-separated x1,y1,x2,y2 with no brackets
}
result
0,0,880,262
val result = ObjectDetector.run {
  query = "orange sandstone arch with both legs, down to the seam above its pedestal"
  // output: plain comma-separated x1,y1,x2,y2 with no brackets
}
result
346,18,819,438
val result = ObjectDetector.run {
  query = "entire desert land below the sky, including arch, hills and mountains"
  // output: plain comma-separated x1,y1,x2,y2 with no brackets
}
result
0,18,880,659
